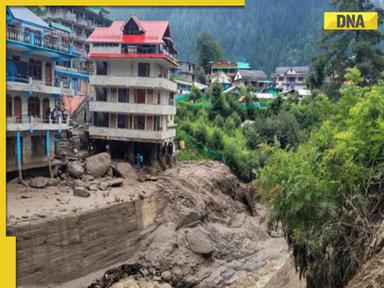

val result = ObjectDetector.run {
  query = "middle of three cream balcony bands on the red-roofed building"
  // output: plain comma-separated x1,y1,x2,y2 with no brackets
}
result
89,101,176,115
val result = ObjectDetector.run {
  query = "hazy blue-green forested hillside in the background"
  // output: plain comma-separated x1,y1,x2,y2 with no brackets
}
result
109,0,330,75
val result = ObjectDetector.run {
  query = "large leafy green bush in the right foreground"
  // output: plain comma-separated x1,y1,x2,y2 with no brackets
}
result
255,68,384,288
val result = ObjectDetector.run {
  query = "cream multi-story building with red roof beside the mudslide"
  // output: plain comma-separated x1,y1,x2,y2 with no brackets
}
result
88,16,177,164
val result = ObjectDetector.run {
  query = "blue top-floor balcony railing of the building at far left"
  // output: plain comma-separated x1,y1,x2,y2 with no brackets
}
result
7,28,72,54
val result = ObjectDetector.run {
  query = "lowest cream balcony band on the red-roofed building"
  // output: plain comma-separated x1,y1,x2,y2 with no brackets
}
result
88,126,176,143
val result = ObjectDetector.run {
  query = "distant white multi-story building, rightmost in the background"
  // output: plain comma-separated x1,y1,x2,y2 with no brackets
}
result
272,66,309,91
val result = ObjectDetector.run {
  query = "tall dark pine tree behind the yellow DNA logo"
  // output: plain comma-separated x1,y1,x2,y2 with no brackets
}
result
309,0,384,88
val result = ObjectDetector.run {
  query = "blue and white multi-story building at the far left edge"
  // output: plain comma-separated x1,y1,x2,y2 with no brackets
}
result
6,7,74,171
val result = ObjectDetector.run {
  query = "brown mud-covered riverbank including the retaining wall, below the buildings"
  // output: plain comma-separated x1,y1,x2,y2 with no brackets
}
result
8,161,300,288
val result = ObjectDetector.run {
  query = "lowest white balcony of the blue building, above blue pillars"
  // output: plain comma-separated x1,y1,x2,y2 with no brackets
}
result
7,115,69,131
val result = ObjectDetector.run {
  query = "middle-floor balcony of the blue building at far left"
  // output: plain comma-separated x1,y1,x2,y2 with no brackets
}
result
7,75,74,96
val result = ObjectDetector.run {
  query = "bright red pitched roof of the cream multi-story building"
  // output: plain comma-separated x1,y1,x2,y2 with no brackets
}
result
87,18,169,44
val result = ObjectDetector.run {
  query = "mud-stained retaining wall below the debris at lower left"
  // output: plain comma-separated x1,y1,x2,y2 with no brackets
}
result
8,197,162,287
